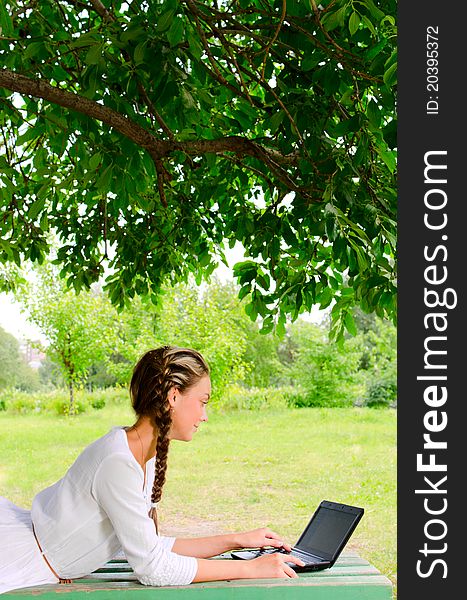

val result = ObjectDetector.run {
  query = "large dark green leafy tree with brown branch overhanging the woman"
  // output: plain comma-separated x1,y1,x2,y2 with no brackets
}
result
0,0,397,337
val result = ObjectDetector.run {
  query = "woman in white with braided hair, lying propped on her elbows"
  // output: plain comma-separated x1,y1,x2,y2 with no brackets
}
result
0,346,301,593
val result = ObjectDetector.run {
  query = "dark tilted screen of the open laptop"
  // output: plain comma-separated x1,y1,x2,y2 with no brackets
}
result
296,506,361,560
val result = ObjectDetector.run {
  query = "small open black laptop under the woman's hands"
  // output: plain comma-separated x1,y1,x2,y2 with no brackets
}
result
231,500,364,572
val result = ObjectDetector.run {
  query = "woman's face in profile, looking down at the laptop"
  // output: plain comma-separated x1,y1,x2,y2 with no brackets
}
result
169,375,211,442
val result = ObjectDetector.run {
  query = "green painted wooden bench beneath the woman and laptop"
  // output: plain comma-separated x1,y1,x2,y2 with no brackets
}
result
2,553,392,600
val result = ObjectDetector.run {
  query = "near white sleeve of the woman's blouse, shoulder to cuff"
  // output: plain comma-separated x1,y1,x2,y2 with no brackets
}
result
93,453,198,586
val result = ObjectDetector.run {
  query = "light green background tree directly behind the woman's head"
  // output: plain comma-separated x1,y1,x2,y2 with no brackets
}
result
108,280,252,397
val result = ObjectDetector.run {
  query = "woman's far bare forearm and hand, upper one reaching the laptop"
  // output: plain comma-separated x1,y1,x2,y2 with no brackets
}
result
172,527,290,558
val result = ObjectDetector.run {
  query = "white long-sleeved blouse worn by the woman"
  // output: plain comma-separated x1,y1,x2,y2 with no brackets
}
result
31,427,197,586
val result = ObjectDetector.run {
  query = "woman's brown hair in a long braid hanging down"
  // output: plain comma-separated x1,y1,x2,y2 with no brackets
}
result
130,346,209,532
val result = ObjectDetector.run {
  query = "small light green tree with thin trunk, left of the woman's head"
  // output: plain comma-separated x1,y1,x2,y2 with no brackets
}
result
23,268,116,415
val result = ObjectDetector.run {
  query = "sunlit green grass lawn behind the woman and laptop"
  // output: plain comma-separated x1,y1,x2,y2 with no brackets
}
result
0,406,396,596
